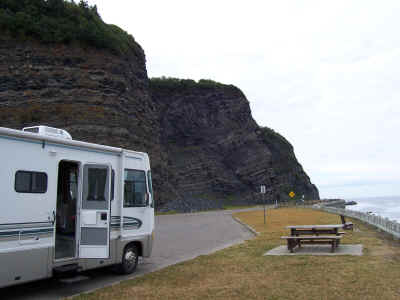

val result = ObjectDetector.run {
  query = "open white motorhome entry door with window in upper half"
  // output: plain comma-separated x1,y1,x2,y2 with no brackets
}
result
79,164,111,258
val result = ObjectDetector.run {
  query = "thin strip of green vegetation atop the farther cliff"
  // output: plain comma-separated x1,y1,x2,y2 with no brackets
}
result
150,76,236,89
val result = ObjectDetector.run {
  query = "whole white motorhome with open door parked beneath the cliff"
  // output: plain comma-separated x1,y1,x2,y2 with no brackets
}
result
0,126,154,287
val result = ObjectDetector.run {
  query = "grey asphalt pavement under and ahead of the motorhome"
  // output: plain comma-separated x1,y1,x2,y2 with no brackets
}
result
0,209,254,300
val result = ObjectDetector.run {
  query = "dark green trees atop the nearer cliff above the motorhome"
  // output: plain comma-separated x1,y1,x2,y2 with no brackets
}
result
0,0,140,54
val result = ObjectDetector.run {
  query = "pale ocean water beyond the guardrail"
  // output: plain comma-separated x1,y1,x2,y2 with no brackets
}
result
346,196,400,222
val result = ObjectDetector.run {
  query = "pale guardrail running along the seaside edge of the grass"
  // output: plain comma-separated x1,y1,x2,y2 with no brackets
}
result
311,204,400,239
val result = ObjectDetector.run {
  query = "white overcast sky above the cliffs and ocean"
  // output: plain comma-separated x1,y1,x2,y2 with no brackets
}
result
89,0,400,199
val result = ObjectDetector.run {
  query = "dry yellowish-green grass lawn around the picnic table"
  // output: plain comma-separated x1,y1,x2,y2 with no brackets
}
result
74,208,400,300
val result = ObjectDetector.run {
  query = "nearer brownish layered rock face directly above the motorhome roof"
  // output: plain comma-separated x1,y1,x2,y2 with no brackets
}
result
0,37,170,202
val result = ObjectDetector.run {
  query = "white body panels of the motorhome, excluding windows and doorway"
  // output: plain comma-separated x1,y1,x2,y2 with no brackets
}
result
0,127,154,287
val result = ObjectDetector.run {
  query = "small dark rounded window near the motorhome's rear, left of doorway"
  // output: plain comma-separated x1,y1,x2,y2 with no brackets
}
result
14,171,47,194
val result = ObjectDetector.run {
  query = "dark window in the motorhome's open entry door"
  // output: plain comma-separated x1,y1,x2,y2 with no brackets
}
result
86,168,107,201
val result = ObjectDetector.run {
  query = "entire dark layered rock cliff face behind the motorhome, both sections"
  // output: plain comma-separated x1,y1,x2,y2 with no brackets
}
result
0,37,319,211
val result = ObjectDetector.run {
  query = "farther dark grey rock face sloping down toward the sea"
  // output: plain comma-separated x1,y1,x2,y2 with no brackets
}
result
150,80,319,209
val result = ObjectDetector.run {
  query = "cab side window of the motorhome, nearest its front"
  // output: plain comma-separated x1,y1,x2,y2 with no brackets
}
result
124,169,146,207
